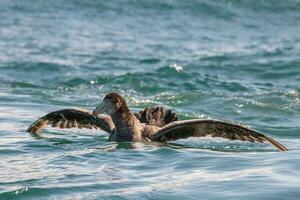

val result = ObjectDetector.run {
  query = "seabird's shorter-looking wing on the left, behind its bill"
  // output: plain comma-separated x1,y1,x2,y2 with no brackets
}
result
27,109,114,133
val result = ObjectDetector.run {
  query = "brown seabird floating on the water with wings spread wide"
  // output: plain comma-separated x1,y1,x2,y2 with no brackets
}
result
27,93,288,151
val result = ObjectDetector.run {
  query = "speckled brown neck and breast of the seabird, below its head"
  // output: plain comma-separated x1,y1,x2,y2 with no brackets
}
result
111,109,141,141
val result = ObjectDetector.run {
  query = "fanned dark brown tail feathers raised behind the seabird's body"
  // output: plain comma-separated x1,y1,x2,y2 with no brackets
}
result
134,107,177,127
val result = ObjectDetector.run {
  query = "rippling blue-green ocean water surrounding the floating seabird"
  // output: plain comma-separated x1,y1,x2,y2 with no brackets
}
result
0,0,300,200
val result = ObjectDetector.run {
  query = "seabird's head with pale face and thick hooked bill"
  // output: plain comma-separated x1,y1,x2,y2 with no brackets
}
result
93,92,129,116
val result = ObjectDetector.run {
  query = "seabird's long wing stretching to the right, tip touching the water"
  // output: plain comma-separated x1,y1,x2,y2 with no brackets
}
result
151,119,288,151
